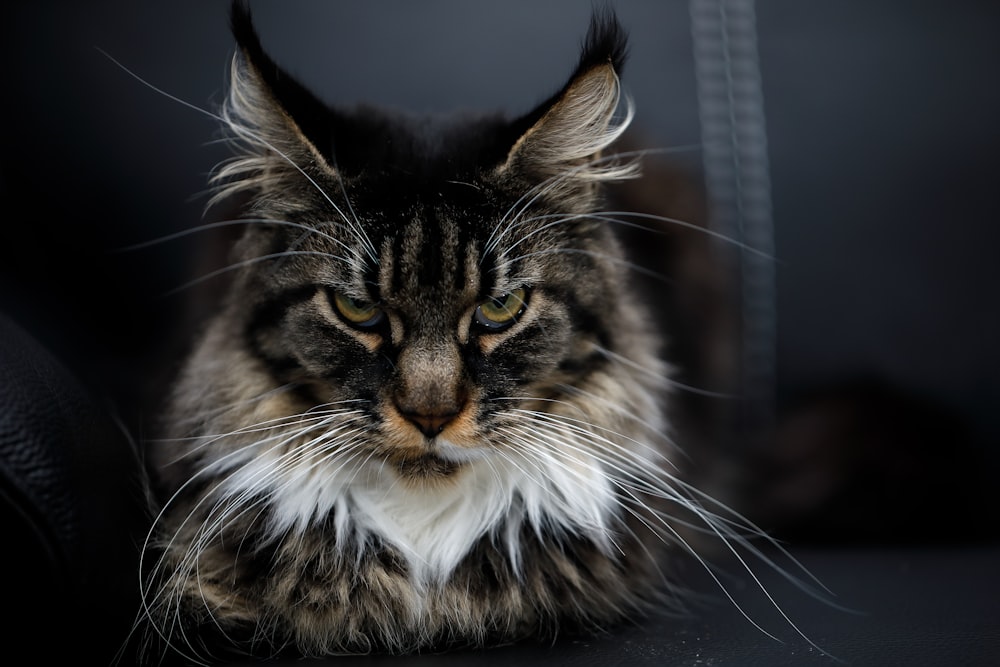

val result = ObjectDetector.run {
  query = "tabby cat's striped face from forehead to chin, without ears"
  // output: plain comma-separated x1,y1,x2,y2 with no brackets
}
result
232,136,635,482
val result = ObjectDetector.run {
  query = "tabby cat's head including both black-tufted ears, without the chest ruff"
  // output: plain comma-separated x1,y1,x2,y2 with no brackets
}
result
176,4,656,488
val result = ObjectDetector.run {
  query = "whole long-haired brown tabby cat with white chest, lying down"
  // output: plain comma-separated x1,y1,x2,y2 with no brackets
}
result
143,3,812,657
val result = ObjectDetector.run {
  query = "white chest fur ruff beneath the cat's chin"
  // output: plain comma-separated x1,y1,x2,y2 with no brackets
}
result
224,438,615,584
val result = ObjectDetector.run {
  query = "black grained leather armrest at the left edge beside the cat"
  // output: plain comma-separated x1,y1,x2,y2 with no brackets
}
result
0,314,143,664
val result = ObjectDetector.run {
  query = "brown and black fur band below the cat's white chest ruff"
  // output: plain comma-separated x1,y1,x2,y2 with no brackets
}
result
158,496,666,656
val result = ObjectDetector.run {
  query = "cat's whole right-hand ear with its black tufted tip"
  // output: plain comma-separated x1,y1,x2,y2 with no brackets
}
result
500,12,637,189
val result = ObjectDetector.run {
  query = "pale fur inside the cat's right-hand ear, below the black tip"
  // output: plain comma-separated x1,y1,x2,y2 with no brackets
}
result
501,63,638,181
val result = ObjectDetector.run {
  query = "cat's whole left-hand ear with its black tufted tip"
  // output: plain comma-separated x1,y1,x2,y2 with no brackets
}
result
215,0,334,204
